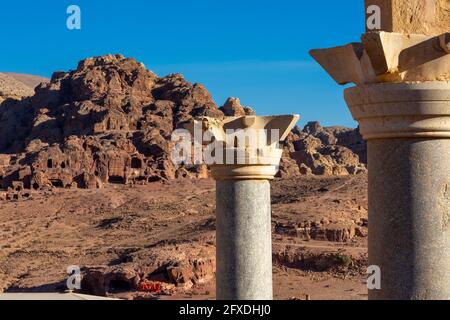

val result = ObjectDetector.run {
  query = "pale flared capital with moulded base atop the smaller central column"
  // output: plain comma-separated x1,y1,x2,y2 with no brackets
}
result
188,115,300,180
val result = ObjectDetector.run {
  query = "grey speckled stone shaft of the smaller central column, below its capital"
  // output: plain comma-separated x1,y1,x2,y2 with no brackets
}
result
212,166,275,300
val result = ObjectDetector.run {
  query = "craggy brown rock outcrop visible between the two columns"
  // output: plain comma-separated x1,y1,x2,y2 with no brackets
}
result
279,122,367,177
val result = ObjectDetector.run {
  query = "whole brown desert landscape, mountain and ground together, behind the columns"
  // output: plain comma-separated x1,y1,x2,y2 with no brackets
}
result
0,59,367,299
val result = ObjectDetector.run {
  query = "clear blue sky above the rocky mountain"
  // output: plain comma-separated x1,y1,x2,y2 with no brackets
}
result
0,0,364,126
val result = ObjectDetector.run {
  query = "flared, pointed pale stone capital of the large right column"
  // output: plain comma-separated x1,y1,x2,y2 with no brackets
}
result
310,32,450,86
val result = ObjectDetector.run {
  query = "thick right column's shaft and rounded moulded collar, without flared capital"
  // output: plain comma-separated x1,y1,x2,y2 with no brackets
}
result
345,82,450,300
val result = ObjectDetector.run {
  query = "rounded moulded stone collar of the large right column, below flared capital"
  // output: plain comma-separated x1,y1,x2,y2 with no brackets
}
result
345,82,450,140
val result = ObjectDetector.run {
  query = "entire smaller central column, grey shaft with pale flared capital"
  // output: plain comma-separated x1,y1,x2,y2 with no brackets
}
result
191,116,299,300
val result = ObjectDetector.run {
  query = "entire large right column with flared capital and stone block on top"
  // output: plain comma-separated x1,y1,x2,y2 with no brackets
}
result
310,0,450,300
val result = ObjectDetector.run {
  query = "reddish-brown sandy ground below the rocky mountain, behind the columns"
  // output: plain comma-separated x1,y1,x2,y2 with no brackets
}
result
0,174,367,300
